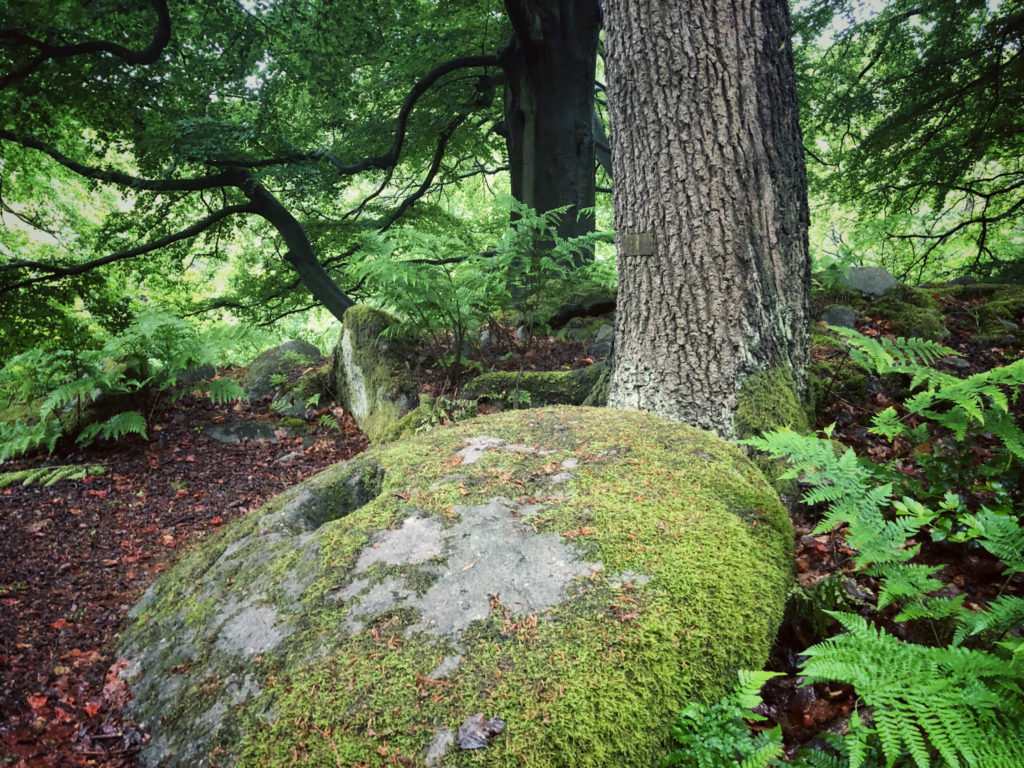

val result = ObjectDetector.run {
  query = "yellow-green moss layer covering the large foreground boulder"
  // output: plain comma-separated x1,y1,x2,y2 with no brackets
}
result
119,408,792,768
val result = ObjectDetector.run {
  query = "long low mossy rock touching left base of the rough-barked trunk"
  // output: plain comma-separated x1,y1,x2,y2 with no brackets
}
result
462,364,607,407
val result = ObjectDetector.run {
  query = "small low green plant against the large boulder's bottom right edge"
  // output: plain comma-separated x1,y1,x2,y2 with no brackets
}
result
662,670,782,768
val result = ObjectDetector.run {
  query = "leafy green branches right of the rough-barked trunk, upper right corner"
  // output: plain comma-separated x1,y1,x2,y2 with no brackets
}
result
795,0,1024,280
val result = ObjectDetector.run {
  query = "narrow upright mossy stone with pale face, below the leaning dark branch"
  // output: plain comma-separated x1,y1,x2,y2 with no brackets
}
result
331,305,419,442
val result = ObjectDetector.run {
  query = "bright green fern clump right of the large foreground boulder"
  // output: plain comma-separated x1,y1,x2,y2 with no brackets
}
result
729,329,1024,768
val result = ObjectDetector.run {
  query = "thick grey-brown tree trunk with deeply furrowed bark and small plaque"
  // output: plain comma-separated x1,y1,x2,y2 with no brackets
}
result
605,0,810,436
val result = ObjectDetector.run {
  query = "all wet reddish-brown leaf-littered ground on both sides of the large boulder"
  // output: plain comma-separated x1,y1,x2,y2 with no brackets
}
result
0,290,1024,768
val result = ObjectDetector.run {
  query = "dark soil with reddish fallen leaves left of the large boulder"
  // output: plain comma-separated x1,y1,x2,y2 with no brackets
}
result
0,398,367,766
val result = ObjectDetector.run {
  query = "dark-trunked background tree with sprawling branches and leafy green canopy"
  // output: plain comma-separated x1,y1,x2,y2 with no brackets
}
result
0,0,600,335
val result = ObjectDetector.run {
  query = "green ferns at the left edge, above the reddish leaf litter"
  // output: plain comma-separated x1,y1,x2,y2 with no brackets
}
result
0,311,244,461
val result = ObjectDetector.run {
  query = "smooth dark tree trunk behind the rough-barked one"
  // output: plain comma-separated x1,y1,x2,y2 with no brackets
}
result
505,0,601,238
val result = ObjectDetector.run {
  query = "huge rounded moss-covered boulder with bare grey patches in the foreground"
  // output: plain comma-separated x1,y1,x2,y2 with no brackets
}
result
121,408,792,768
